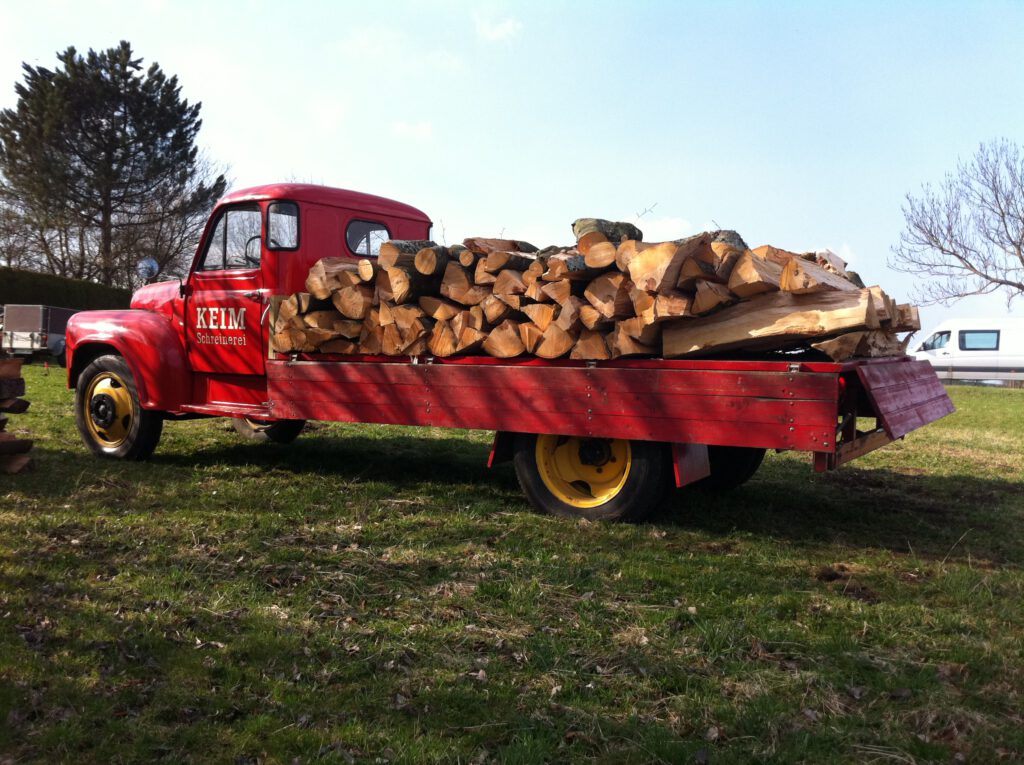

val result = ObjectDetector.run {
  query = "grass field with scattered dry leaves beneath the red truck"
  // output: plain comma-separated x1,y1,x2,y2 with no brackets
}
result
0,367,1024,763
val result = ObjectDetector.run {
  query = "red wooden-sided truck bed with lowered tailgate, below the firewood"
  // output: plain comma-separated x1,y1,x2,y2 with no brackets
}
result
267,356,953,469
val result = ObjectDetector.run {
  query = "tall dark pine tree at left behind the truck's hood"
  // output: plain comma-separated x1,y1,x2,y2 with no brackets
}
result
0,41,226,287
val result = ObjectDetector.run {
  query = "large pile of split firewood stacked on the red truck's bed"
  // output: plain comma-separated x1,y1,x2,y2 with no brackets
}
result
271,218,920,360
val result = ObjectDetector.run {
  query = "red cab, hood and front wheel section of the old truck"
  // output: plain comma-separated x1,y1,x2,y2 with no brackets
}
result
68,183,431,448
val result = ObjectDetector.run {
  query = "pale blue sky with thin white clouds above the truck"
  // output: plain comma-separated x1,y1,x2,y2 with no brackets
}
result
0,0,1024,332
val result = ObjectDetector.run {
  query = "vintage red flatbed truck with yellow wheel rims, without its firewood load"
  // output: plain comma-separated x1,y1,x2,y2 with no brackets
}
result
67,183,953,519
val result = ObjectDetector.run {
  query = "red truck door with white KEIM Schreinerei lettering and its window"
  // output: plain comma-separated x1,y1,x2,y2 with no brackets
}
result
185,204,266,375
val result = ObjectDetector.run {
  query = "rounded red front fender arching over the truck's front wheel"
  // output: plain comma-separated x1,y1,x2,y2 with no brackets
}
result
67,310,191,412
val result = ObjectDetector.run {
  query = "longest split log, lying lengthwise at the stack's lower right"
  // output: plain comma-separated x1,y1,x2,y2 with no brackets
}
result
662,290,879,358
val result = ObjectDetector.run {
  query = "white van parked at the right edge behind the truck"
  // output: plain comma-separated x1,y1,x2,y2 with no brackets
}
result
913,317,1024,380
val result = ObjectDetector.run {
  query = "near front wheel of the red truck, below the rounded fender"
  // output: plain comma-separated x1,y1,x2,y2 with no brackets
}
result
75,355,164,460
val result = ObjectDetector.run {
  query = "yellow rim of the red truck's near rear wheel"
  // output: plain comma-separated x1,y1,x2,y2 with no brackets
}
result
537,435,632,507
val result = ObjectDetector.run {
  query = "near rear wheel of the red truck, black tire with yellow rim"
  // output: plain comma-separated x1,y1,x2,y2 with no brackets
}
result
513,434,668,521
